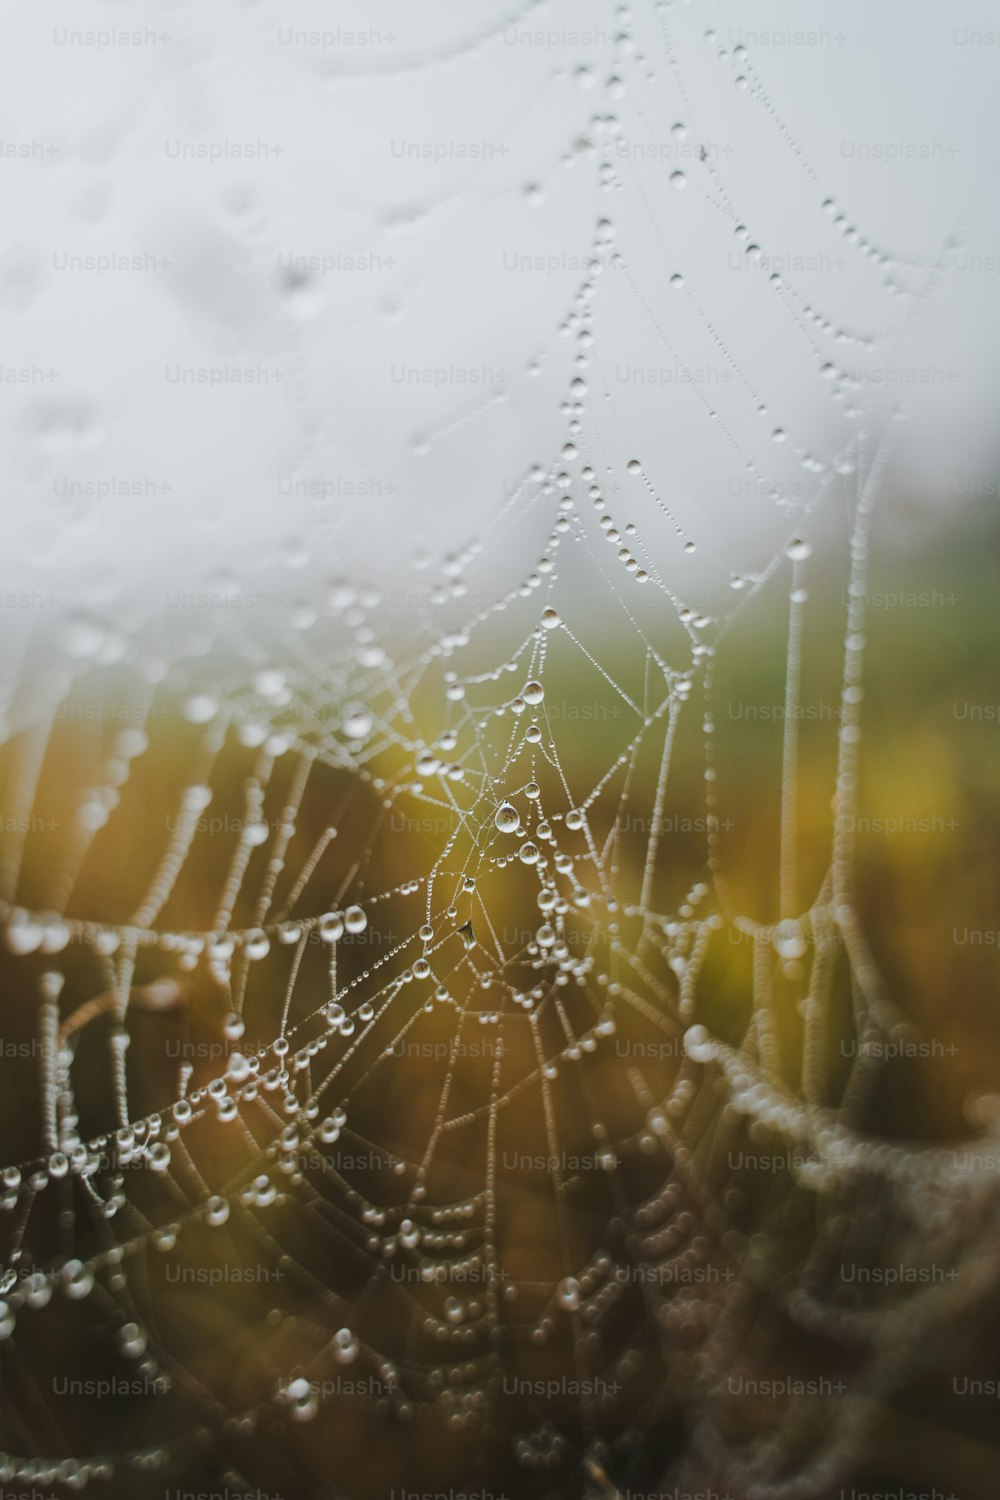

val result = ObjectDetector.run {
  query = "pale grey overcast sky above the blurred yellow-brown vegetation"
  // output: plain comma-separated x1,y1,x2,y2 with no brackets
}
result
0,0,1000,617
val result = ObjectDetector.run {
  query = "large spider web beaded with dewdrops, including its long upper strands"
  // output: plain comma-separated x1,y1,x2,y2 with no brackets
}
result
0,6,996,1497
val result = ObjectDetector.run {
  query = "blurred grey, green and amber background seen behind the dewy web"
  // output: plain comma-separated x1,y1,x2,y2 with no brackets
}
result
0,0,1000,1500
